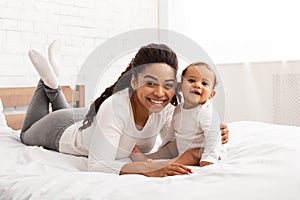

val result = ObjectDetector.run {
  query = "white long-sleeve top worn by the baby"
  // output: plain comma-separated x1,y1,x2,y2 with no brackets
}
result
171,100,221,163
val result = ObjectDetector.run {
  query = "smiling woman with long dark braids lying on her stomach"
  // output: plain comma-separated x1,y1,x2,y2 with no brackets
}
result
21,44,227,177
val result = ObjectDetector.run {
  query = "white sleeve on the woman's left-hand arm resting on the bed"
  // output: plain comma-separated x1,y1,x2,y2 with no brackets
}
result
88,100,126,174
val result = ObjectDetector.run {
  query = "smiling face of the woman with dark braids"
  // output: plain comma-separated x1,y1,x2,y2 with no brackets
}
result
131,63,176,112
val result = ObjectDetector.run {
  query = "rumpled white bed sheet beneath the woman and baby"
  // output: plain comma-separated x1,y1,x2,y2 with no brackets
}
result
0,121,300,200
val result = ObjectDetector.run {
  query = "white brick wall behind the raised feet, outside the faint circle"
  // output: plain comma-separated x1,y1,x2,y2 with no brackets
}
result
0,0,161,87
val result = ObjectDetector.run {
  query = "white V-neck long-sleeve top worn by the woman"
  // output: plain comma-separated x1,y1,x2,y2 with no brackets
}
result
59,89,174,174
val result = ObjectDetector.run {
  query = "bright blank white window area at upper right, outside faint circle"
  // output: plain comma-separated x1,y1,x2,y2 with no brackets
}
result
168,0,300,64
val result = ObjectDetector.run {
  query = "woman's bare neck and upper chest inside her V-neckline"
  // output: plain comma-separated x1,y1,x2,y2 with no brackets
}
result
130,92,149,129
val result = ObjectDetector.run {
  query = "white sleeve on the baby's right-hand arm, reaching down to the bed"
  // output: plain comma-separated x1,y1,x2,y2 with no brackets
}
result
200,104,221,163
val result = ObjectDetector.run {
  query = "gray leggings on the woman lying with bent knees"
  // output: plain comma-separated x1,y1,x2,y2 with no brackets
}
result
20,80,86,151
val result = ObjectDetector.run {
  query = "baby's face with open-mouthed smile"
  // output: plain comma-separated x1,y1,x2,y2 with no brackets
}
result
181,65,215,108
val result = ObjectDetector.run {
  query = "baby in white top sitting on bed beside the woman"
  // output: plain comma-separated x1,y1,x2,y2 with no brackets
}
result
131,62,225,167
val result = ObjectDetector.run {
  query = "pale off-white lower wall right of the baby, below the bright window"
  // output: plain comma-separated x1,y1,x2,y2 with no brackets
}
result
217,61,300,126
